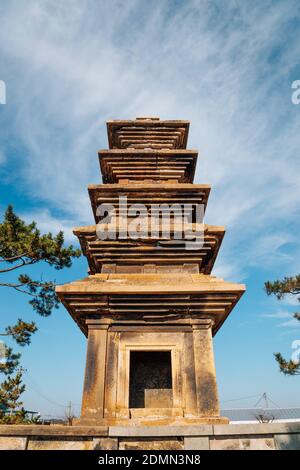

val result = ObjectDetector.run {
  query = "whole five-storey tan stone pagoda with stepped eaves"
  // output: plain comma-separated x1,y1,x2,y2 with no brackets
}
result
57,118,245,425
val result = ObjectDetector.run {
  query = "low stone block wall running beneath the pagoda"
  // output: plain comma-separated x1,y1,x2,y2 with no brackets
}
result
0,422,300,451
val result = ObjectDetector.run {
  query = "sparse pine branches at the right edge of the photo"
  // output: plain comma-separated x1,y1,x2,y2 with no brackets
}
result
265,274,300,375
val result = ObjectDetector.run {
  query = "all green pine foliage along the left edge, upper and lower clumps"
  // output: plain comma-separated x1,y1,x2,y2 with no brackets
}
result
0,206,81,422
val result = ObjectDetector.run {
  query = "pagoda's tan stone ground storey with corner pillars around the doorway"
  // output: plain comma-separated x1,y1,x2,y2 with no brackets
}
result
78,319,227,425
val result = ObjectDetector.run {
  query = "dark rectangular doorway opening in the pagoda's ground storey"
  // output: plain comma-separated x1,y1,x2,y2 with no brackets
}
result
129,351,173,408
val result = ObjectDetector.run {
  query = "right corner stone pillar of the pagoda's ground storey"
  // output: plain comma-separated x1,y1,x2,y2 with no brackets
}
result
192,319,220,416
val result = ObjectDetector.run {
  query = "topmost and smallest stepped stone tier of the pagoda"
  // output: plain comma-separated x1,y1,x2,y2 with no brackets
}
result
107,117,190,150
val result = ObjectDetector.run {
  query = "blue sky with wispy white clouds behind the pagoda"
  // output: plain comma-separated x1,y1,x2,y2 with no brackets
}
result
0,0,300,416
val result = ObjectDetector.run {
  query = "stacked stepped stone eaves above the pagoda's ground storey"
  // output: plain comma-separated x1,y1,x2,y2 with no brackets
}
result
57,118,245,333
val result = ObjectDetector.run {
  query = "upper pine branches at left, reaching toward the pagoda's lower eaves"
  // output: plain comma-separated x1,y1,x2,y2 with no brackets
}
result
0,206,80,316
